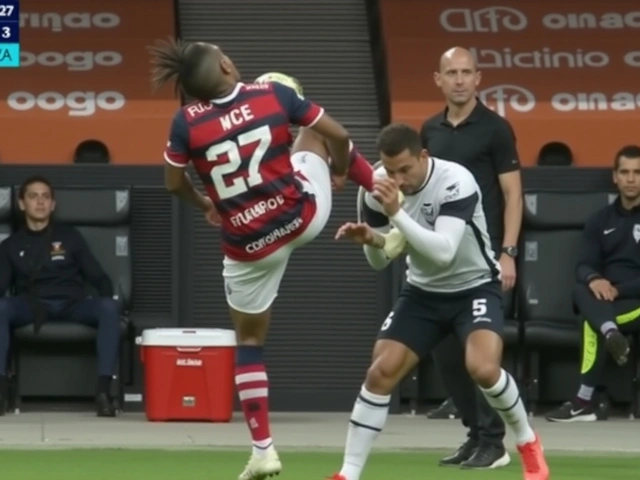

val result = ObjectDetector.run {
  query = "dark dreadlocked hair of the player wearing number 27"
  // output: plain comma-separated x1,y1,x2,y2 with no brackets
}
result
148,38,219,101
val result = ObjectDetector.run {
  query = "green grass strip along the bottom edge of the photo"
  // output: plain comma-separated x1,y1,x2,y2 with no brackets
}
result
0,450,640,480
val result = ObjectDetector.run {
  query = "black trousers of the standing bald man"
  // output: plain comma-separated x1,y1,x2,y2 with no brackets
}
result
433,239,506,445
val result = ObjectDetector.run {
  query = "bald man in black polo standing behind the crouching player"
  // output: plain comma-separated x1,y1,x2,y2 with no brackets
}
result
421,47,522,468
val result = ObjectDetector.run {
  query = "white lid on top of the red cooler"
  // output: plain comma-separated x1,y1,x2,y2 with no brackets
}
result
136,328,236,347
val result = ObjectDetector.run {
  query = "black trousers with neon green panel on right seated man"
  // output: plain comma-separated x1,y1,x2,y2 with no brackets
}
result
573,285,640,388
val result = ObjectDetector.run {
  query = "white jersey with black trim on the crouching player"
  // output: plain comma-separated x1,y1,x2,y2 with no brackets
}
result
364,157,500,292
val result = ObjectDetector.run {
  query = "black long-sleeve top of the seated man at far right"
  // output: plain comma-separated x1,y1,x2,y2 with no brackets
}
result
576,199,640,298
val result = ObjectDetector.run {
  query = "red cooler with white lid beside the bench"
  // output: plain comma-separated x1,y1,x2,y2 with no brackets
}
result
136,328,236,422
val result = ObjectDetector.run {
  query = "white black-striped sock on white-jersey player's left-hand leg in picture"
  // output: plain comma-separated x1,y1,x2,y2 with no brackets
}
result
340,385,391,480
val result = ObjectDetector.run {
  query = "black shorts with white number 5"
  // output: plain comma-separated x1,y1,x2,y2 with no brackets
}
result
378,282,504,358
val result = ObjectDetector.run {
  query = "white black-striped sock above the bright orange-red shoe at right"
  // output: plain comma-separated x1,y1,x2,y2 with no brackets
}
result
480,370,536,445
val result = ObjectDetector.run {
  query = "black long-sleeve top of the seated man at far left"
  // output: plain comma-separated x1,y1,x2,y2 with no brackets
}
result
0,224,113,299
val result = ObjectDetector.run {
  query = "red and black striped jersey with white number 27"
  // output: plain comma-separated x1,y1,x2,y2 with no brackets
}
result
164,83,324,261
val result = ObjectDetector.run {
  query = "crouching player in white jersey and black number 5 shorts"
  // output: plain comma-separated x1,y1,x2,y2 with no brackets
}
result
332,124,549,480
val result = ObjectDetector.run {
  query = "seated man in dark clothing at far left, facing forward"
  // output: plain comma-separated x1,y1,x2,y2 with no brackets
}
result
0,176,120,417
